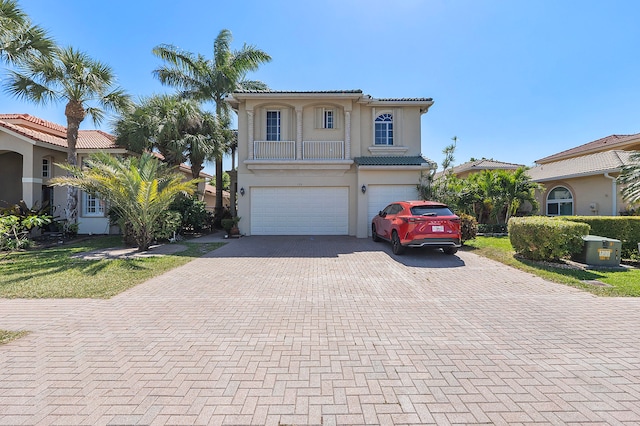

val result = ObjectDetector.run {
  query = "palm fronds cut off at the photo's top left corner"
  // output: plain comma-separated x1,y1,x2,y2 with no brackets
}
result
0,0,55,64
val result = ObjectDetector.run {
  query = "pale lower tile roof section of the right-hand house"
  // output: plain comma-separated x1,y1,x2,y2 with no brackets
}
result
527,150,634,182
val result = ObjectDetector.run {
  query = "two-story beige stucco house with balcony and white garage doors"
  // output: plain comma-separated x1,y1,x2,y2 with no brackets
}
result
227,90,435,238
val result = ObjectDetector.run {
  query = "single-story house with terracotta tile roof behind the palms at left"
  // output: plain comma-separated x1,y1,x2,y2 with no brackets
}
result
0,114,222,234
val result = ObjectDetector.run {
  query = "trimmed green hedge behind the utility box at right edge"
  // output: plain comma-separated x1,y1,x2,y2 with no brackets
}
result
556,216,640,259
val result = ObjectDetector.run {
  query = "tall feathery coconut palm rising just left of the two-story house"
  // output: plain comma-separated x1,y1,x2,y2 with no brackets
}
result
153,29,271,217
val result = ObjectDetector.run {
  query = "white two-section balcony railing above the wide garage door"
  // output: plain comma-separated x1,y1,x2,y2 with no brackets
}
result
253,141,345,160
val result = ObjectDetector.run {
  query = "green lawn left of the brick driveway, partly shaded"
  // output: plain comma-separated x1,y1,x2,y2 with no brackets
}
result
0,236,224,299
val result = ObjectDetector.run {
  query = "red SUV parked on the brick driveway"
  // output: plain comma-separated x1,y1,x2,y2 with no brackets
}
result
371,201,462,254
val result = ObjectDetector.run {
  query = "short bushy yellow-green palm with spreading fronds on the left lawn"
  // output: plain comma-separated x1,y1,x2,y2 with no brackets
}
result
51,152,199,251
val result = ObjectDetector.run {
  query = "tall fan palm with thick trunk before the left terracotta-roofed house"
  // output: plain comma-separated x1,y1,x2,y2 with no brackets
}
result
7,47,130,224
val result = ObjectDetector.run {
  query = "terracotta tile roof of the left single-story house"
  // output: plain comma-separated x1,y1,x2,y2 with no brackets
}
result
0,114,122,150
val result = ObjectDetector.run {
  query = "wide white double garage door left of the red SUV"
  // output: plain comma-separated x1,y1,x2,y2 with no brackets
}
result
251,187,349,235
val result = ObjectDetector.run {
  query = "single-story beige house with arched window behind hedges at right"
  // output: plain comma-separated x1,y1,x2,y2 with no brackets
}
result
528,133,640,216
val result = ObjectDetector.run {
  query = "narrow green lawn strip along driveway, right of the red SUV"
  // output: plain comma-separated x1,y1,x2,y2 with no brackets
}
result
464,237,640,297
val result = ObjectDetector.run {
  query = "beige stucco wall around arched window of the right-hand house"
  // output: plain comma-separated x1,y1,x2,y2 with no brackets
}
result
536,174,627,216
